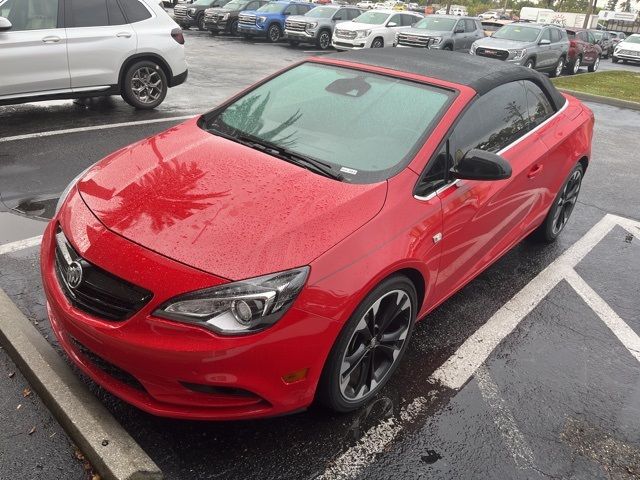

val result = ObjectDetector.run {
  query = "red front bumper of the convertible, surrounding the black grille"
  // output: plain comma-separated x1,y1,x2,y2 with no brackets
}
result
41,191,340,420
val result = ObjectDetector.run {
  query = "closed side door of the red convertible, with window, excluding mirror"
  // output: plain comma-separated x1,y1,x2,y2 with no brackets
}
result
428,81,547,303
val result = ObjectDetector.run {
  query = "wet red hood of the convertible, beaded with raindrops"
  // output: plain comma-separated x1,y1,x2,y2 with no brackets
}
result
78,120,387,280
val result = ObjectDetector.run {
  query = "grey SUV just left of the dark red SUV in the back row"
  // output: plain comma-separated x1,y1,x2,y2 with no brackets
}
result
469,23,569,77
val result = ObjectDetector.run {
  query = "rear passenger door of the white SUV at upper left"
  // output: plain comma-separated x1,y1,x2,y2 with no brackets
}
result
65,0,138,90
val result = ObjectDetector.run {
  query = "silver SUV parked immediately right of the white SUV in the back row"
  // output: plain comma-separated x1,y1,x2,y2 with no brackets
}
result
396,15,484,52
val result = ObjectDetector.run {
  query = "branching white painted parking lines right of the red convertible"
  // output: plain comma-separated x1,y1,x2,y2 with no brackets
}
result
319,214,640,480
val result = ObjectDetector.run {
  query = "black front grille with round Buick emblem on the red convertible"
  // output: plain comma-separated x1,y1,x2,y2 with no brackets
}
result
55,227,152,321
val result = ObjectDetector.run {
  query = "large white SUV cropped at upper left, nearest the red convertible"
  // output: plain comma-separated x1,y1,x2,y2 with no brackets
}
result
0,0,187,109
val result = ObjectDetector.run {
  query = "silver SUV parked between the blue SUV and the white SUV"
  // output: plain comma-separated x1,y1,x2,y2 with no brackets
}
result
284,5,362,50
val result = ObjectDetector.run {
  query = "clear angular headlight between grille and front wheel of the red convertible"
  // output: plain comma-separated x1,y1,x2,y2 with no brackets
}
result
154,267,309,335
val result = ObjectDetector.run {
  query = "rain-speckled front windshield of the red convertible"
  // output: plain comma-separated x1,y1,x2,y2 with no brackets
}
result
200,63,454,183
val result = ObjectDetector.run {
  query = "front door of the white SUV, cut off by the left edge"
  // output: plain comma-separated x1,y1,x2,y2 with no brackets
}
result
0,0,70,97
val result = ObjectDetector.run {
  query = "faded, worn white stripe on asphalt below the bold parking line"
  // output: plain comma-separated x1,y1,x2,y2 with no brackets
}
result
475,366,534,470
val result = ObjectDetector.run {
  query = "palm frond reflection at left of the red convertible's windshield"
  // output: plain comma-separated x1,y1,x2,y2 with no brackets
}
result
221,94,302,147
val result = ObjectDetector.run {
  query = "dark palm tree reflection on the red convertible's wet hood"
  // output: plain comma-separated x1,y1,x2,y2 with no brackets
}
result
103,159,229,233
